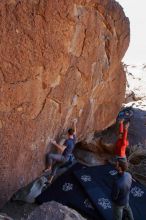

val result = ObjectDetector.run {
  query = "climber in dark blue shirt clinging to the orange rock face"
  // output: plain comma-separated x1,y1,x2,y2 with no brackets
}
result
45,120,77,183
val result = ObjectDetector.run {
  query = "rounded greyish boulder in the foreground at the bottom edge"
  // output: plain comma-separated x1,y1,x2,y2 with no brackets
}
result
23,201,85,220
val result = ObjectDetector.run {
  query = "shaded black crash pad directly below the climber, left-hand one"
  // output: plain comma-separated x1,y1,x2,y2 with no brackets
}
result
36,163,102,220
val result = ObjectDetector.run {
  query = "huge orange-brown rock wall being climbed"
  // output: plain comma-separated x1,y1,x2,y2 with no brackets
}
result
0,0,129,206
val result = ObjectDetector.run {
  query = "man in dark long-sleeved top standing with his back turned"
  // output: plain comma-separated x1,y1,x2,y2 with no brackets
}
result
112,160,134,220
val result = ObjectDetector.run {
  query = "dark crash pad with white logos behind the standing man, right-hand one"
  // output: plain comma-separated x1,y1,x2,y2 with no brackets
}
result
74,165,146,220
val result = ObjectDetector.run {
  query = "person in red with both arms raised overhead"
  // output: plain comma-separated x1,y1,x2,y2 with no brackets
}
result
115,119,129,161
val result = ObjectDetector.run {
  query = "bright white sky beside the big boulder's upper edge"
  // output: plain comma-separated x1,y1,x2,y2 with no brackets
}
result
116,0,146,64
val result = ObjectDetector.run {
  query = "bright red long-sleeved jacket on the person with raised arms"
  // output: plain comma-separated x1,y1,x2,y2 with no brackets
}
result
115,122,129,157
